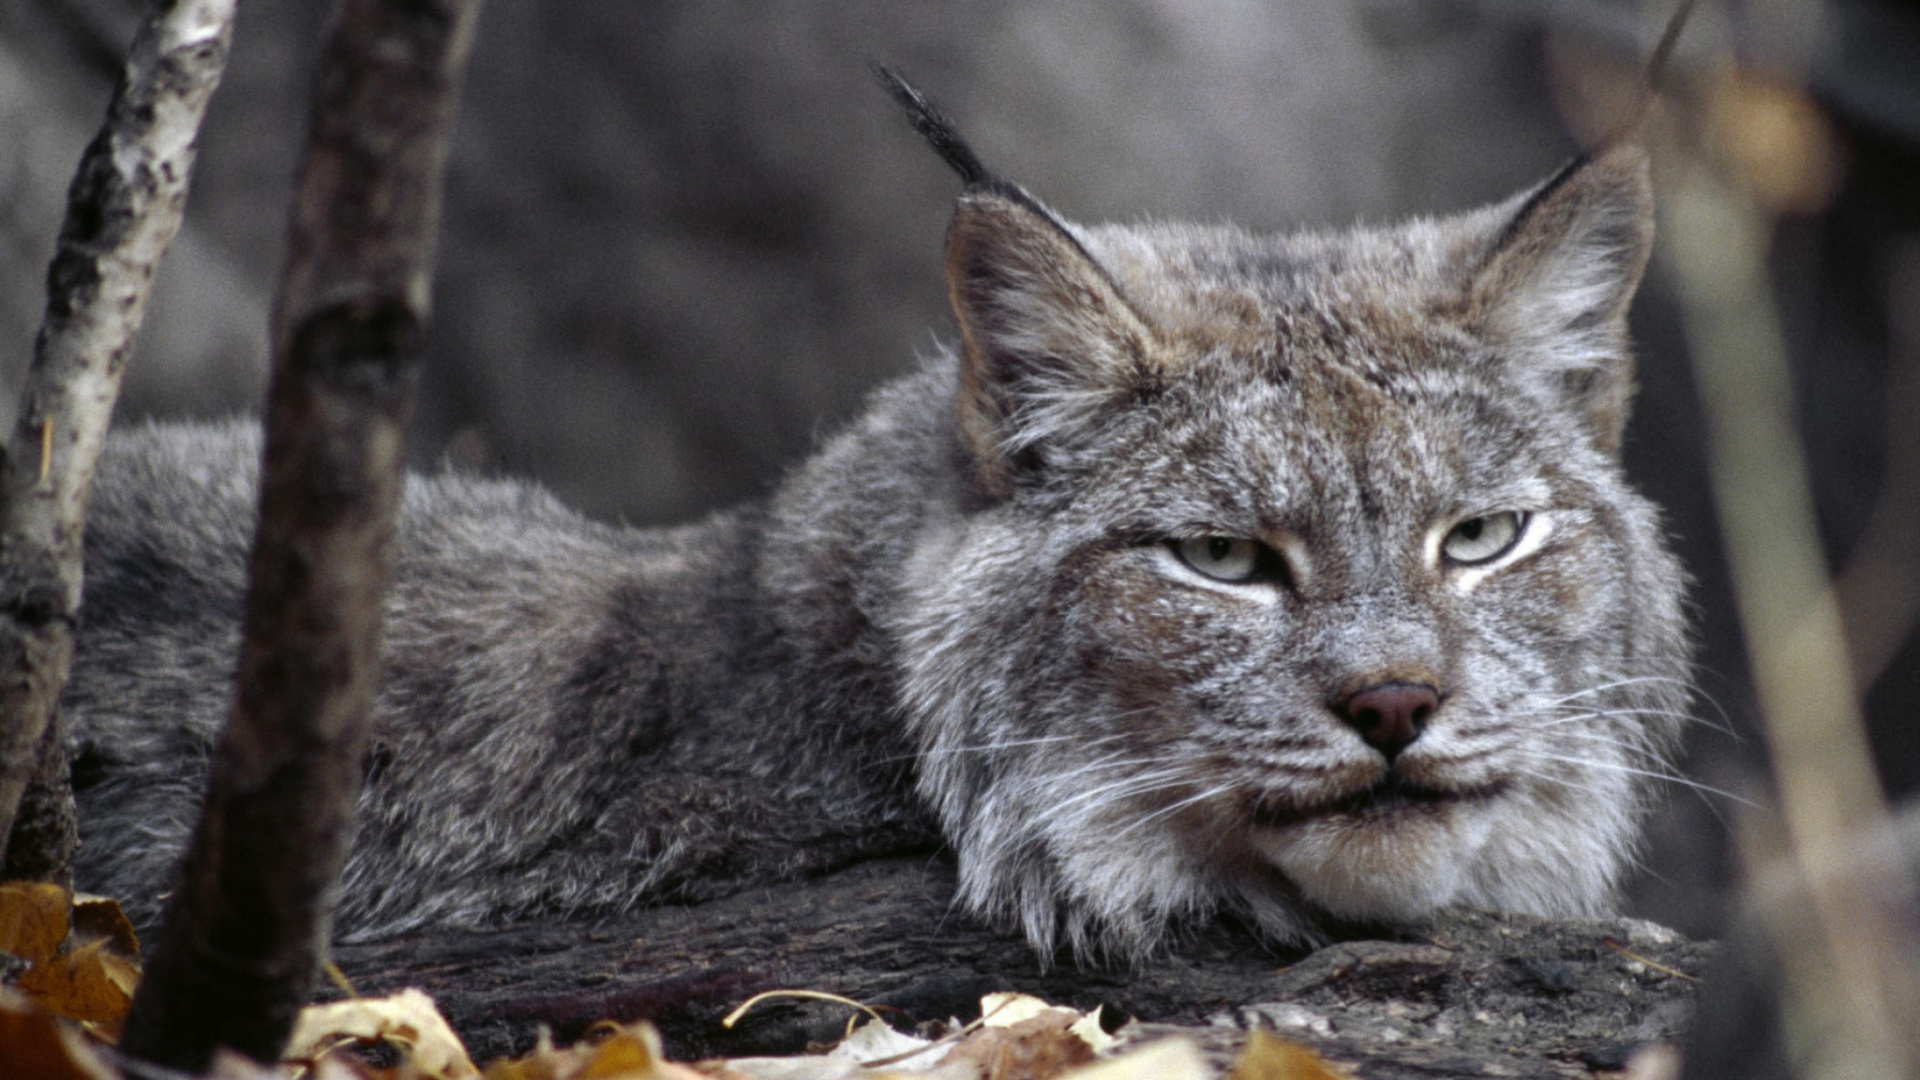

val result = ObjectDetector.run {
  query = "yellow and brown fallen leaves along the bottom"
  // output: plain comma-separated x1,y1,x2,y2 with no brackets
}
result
0,882,1348,1080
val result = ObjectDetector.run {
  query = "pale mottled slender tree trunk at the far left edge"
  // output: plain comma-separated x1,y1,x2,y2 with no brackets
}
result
0,0,234,884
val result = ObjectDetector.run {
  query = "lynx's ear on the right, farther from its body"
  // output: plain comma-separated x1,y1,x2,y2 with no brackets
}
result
1467,144,1653,452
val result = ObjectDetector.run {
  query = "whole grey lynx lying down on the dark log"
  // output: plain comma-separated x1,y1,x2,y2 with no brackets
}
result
63,77,1690,957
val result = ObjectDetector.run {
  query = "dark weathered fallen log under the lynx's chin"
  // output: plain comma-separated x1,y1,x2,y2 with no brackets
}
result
334,857,1711,1078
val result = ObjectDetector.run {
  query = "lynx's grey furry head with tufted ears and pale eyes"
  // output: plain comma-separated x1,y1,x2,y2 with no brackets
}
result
883,71,1690,953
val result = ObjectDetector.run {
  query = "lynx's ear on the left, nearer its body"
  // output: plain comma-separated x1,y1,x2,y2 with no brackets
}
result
947,183,1154,498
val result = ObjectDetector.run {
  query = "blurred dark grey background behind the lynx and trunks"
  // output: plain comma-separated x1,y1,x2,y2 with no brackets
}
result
0,0,1920,934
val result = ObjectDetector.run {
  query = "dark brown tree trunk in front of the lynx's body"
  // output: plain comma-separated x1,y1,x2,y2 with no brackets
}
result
121,0,478,1072
